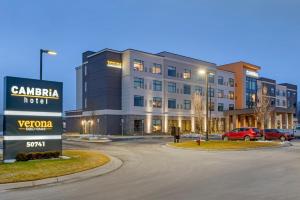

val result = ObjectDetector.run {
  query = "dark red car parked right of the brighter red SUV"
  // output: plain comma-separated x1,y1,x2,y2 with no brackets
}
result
264,129,295,142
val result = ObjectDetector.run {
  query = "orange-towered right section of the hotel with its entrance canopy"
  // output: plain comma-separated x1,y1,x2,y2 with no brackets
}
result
219,62,297,130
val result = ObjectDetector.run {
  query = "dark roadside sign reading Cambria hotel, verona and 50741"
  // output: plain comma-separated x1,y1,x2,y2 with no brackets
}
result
3,77,63,162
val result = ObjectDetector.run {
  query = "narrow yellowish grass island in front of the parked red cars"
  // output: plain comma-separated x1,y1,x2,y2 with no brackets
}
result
169,141,280,150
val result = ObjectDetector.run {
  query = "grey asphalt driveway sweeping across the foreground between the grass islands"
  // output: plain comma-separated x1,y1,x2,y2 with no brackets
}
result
0,140,300,200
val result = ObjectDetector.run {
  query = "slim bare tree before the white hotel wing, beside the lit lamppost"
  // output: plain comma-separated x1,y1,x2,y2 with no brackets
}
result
192,92,204,134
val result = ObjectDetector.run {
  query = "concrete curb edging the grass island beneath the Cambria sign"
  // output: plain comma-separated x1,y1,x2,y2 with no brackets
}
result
0,155,123,193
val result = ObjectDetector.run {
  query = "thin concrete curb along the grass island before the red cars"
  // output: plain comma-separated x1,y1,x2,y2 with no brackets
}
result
163,143,293,152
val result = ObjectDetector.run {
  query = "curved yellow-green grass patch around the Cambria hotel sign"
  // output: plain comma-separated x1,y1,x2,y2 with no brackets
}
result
0,150,110,183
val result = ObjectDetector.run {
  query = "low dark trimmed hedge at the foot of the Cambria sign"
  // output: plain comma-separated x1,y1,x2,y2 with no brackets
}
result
16,151,60,161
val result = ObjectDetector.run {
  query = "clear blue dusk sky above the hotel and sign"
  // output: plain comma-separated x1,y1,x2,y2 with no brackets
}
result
0,0,300,110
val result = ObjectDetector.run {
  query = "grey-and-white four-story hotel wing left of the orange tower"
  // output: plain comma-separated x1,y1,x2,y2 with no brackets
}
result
66,49,235,134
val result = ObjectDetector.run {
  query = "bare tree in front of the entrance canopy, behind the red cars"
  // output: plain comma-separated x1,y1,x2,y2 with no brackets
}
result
254,87,274,129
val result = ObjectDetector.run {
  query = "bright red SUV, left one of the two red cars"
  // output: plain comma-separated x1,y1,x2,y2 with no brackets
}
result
222,128,261,141
